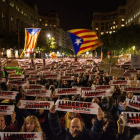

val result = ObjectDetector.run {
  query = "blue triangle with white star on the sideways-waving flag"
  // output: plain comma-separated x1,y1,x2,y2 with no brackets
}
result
69,33,84,55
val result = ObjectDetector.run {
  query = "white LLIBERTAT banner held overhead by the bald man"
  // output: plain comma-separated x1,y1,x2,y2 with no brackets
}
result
55,100,99,114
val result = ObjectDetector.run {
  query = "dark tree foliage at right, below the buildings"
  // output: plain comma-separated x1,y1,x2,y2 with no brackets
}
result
101,24,140,54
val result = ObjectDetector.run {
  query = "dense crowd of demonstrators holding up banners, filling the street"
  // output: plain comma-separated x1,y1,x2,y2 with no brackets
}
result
0,57,140,140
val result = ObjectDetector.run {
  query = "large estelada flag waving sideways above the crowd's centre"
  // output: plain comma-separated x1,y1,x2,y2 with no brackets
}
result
68,29,103,55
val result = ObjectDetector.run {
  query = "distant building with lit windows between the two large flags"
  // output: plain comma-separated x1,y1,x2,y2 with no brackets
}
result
39,11,68,48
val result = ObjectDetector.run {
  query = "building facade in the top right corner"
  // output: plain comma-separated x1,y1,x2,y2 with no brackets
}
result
126,0,140,25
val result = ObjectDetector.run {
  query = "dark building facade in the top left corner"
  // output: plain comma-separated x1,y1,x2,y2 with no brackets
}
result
0,0,38,36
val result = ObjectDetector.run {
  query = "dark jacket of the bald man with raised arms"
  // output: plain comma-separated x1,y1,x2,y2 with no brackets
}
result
48,113,103,140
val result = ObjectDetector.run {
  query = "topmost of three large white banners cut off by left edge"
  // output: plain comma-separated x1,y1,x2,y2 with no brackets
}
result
0,90,18,100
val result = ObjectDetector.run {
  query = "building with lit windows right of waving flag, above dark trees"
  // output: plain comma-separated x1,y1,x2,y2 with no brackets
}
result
91,6,126,37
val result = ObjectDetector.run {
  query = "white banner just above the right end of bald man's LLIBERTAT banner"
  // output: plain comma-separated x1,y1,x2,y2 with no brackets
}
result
82,89,112,98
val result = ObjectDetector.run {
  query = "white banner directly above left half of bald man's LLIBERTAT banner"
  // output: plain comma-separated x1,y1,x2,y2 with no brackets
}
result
55,87,81,95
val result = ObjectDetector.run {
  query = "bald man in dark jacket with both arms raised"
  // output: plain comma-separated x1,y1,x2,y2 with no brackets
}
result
48,105,104,140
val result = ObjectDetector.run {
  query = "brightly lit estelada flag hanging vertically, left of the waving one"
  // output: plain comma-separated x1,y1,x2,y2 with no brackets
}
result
24,28,41,51
